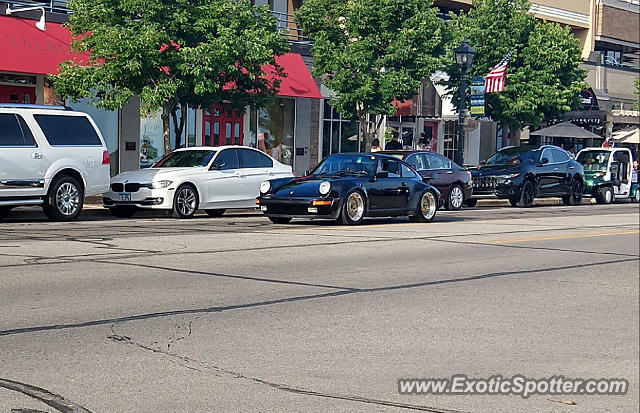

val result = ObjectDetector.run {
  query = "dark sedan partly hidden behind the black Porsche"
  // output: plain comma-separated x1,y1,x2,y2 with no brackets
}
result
379,150,473,210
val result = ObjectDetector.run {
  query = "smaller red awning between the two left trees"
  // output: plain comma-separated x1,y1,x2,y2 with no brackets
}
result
265,53,322,99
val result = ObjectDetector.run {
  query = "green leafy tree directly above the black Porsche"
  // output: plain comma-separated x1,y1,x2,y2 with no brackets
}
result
296,0,444,146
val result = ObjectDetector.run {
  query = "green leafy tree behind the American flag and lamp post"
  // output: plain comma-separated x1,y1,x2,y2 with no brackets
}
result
445,0,588,138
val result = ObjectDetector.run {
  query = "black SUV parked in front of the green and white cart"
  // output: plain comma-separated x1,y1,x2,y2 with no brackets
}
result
467,145,584,207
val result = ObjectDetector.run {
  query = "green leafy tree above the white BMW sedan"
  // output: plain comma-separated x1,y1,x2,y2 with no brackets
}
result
54,0,289,153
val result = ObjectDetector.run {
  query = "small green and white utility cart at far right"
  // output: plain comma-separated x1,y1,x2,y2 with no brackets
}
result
576,147,640,204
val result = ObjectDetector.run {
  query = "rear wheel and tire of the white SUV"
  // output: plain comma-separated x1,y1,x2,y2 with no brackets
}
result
42,175,84,222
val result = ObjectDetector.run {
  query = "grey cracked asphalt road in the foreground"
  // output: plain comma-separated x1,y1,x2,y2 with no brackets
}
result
0,203,640,413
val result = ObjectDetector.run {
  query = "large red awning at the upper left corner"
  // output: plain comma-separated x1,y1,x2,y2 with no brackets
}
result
0,16,88,75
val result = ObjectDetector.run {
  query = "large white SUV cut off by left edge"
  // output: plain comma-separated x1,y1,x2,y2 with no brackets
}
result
0,104,110,221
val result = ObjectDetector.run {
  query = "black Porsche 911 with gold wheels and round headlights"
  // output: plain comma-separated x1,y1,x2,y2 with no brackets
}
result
256,153,443,225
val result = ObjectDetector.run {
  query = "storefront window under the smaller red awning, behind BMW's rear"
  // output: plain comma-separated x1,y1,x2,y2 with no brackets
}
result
250,98,296,166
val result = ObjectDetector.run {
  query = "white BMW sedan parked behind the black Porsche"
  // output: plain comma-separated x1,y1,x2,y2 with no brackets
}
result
103,146,294,218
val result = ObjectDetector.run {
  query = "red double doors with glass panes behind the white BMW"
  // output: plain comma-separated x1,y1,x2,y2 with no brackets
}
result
202,104,244,146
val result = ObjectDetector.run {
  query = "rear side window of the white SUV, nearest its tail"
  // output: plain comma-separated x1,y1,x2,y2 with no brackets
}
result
33,115,102,146
